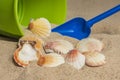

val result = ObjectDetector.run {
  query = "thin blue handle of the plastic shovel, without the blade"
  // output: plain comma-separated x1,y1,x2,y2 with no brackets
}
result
87,4,120,27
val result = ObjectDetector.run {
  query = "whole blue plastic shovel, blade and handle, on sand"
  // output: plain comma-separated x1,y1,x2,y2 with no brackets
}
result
52,4,120,40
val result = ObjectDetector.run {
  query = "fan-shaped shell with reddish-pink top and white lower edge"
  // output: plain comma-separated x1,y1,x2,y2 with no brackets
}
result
65,49,85,69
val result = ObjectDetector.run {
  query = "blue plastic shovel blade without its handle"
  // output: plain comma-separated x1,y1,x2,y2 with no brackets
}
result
52,17,91,40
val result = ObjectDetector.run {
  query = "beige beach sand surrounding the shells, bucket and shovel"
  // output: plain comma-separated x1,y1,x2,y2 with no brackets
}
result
0,0,120,80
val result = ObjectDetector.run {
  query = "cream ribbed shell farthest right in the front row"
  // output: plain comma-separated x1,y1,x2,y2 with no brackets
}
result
85,52,106,67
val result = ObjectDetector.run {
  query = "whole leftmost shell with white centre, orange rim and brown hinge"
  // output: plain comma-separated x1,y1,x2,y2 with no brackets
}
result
14,36,43,67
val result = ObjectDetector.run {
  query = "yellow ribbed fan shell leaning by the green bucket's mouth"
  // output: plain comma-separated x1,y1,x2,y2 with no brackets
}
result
28,18,51,38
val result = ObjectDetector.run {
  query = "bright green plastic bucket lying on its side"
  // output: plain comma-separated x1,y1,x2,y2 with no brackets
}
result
0,0,66,38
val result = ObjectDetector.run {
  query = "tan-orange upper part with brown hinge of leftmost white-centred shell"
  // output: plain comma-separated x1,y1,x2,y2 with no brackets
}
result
18,35,44,52
